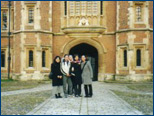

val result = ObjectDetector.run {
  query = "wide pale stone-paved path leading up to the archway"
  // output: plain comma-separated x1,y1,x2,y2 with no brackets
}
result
27,82,142,115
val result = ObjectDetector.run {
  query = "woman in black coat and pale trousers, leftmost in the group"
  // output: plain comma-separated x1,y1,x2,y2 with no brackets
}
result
51,56,63,98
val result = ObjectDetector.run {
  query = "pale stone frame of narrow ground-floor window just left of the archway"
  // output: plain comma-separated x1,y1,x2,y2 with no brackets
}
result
41,47,50,70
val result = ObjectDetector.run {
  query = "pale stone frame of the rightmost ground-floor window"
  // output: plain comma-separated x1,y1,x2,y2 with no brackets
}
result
134,44,146,70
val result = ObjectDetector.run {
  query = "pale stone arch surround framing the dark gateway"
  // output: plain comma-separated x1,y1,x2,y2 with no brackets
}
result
61,38,107,81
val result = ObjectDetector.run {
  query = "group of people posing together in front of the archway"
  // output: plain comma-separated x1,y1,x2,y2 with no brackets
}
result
51,54,93,98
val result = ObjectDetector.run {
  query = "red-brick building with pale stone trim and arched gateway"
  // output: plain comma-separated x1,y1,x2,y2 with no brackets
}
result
1,1,153,81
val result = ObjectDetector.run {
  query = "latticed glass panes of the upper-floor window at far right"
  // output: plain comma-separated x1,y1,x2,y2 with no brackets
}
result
136,5,142,22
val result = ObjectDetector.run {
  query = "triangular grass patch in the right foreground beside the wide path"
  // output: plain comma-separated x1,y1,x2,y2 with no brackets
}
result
112,89,153,115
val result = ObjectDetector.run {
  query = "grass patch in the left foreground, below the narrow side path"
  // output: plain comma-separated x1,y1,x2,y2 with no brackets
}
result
1,91,51,115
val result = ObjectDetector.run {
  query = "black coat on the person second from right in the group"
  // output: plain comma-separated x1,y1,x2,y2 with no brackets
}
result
70,62,82,85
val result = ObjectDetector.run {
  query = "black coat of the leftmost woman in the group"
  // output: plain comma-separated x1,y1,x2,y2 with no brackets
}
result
51,63,63,86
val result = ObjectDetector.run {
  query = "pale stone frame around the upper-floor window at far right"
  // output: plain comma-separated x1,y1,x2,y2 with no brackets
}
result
134,1,145,24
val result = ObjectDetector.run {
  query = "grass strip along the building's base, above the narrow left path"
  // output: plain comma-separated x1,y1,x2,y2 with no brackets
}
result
1,80,51,92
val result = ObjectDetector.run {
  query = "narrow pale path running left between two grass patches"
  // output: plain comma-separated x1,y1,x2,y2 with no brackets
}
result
1,84,52,96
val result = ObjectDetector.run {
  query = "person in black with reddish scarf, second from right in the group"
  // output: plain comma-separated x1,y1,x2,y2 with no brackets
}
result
70,55,82,97
